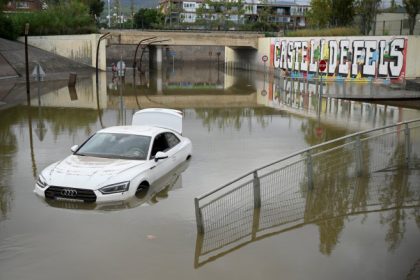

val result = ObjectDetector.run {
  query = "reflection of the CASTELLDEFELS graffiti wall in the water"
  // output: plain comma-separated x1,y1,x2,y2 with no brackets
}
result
256,72,420,134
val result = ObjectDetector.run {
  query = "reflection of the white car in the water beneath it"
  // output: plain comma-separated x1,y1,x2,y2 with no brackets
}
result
40,161,190,211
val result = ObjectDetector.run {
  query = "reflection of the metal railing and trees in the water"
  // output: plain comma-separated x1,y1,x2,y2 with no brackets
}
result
194,169,420,268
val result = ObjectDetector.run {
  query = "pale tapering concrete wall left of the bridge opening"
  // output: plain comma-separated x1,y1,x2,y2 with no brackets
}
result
19,34,107,70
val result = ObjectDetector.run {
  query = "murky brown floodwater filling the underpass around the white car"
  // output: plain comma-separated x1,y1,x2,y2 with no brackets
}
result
0,63,420,280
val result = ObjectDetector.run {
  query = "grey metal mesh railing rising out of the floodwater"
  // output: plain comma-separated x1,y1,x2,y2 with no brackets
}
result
194,119,420,236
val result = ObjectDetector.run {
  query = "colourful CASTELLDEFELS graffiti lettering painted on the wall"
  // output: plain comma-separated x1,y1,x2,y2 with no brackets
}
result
270,36,407,82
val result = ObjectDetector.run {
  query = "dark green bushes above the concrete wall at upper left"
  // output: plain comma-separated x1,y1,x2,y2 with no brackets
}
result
0,1,97,40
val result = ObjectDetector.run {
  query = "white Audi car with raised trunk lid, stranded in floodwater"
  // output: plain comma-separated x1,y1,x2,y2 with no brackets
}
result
34,108,192,202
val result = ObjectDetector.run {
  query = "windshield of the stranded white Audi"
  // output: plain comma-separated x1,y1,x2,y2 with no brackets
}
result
75,133,151,160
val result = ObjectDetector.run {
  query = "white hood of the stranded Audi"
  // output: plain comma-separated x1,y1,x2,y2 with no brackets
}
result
43,155,144,189
